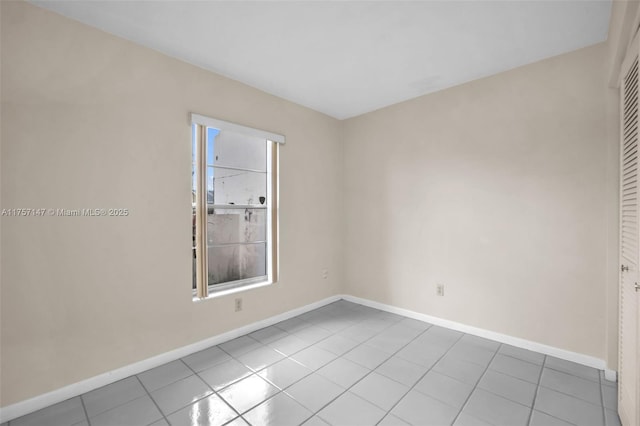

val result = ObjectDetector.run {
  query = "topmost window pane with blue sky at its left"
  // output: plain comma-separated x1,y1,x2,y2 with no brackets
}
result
207,128,267,172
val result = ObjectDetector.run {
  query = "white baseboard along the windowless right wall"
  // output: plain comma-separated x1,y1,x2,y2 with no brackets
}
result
343,295,612,373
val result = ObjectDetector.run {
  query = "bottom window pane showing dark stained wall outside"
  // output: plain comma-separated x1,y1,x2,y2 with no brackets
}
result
208,243,267,285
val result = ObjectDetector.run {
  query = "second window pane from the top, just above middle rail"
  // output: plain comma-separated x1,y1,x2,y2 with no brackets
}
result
207,167,267,206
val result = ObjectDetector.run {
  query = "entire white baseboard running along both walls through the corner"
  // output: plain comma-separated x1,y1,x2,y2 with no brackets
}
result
0,295,616,423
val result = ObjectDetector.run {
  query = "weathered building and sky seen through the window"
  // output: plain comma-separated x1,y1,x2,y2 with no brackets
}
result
192,118,272,289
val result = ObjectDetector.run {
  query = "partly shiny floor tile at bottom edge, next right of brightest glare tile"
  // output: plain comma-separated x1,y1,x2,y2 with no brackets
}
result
242,393,313,426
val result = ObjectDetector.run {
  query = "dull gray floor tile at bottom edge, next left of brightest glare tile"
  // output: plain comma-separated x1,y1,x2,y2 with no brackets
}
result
90,395,162,426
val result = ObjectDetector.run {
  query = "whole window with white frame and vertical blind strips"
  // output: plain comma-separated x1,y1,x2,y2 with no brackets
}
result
191,114,284,298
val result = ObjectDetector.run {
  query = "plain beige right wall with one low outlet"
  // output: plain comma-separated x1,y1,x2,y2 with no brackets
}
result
344,45,609,359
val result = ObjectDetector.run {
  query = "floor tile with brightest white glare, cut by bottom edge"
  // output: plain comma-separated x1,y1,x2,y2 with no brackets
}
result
167,394,238,426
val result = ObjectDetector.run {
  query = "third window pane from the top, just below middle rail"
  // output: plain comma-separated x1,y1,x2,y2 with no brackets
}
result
207,208,267,245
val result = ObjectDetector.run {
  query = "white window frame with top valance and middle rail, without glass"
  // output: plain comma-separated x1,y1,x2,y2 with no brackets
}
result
191,113,285,300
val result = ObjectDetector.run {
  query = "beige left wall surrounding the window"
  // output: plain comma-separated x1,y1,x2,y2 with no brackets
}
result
0,1,343,406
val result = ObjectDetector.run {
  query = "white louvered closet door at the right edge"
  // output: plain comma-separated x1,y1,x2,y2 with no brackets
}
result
618,32,640,426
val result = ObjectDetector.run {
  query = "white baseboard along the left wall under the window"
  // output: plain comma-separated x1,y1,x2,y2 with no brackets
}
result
0,295,342,423
